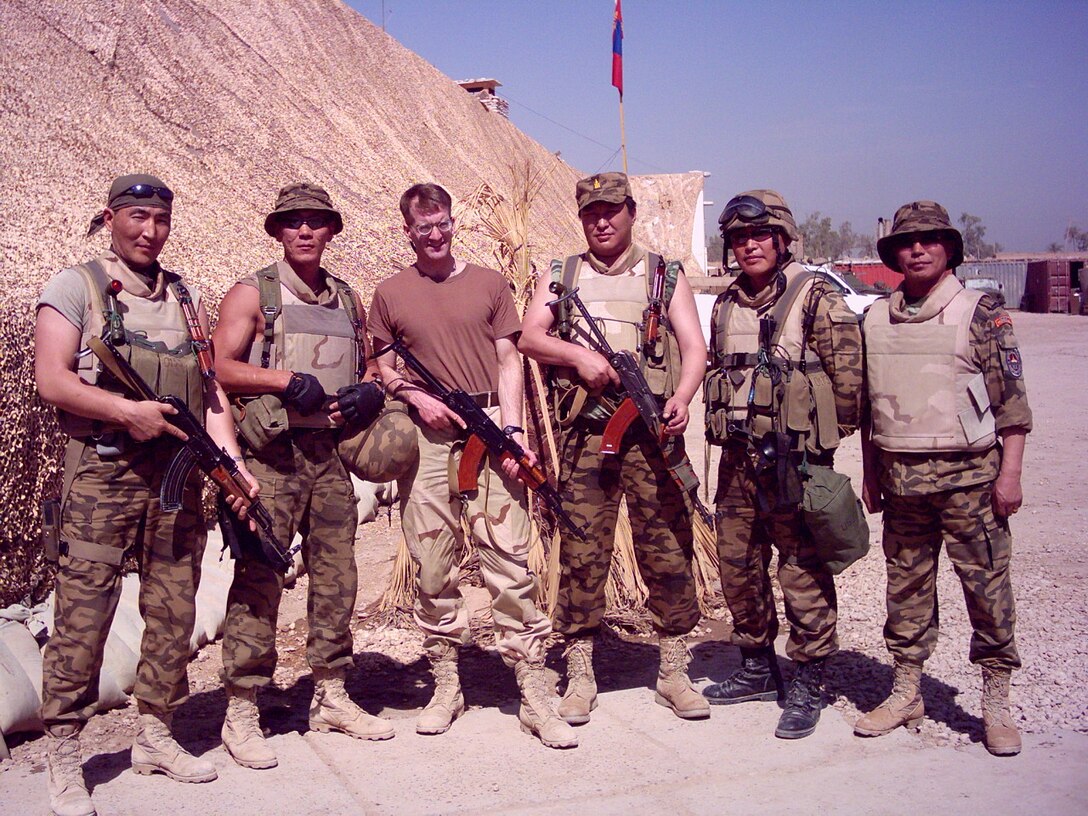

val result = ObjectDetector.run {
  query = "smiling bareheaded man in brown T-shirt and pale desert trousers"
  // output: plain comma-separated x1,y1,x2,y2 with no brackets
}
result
370,184,578,747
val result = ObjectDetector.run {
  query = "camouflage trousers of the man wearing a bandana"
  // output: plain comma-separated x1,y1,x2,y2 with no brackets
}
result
41,440,206,730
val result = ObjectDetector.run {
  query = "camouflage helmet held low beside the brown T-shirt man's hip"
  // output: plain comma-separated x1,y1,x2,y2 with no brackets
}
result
337,399,419,484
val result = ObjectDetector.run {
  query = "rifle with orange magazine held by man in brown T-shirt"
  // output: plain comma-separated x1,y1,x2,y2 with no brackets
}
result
379,337,585,539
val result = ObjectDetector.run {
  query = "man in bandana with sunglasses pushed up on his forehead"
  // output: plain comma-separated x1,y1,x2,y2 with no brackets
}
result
34,175,256,816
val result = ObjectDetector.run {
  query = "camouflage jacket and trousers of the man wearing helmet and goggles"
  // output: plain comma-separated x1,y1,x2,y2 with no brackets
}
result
710,276,863,663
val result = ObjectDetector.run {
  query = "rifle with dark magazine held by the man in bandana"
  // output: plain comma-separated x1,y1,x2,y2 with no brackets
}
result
87,281,301,571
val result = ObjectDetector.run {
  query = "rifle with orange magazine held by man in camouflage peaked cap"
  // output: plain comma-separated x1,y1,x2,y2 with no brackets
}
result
548,281,714,529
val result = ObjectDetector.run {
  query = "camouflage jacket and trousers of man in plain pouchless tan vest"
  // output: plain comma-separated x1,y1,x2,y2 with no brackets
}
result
880,296,1031,669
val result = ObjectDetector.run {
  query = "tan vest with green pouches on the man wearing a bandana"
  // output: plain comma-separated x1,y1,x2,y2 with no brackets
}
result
57,258,203,440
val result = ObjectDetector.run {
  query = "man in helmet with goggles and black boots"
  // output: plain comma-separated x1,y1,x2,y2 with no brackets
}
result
703,189,862,739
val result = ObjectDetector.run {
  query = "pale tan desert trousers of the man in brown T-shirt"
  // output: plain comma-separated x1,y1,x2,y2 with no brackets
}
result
400,408,552,666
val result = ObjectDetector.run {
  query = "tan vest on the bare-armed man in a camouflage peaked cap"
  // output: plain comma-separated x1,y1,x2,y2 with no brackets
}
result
549,252,683,425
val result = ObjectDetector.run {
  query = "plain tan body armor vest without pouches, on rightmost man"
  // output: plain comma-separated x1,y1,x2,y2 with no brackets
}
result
865,275,997,453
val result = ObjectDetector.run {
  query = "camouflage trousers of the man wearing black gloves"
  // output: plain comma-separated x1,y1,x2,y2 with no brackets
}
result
223,430,359,689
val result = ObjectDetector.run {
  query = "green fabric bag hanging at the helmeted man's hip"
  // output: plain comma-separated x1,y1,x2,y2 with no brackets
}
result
801,465,869,574
